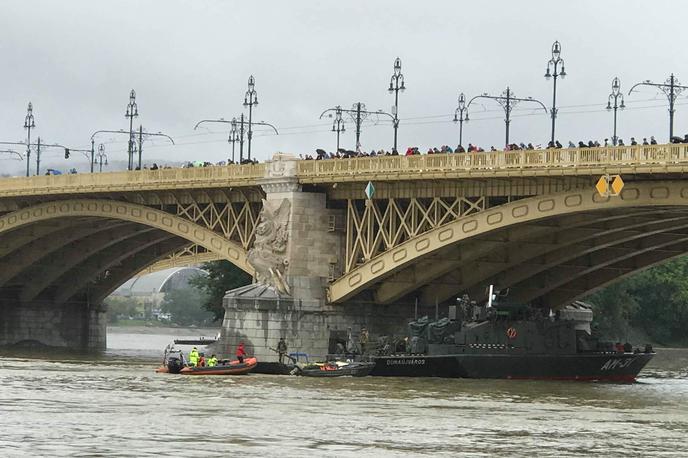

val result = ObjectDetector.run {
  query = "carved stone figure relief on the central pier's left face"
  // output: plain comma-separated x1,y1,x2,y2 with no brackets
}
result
248,199,291,294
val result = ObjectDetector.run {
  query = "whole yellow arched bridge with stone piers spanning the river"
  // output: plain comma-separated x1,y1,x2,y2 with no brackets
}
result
0,144,688,348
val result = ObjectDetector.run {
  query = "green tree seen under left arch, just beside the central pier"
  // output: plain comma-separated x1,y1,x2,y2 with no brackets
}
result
189,261,251,321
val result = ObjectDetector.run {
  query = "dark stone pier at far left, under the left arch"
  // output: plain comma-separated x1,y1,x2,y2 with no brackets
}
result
0,302,107,350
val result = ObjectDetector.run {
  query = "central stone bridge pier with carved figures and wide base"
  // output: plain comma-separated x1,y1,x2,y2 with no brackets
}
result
217,154,409,369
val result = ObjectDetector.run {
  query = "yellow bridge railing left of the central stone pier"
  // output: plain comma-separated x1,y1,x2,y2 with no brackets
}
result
0,164,265,196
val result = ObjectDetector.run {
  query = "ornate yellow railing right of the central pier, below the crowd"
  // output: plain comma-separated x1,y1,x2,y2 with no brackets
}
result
299,144,688,178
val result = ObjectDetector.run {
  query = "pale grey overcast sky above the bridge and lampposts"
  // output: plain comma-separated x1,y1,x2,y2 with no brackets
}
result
0,0,688,172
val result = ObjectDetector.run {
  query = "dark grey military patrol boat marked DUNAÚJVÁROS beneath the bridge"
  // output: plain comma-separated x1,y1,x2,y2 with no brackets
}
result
371,288,655,382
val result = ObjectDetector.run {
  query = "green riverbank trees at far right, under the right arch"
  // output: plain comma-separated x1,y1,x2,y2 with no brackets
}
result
586,257,688,345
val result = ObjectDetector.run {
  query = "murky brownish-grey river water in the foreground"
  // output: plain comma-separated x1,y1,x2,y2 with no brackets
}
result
0,330,688,457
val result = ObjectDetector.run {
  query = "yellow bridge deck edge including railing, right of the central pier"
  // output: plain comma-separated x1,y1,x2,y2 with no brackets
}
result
299,144,688,184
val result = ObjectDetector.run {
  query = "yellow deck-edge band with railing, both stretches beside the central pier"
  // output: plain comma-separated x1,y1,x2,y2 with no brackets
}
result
0,144,688,197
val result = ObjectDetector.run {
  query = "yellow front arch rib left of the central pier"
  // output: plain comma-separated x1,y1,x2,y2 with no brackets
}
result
0,199,253,274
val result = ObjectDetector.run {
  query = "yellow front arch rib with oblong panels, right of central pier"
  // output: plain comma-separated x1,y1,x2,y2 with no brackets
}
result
329,181,688,302
